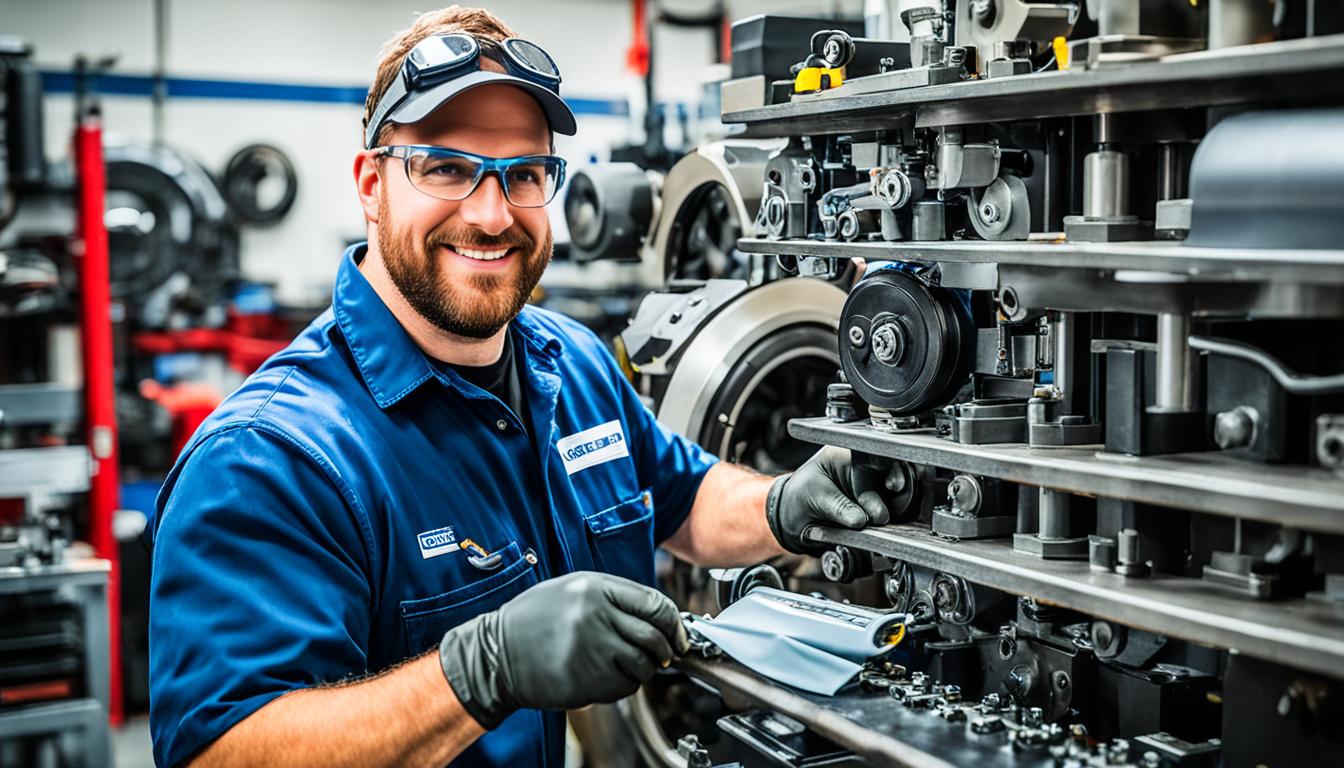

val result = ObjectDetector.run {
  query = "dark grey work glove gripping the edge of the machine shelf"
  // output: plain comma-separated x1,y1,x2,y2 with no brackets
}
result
765,445,891,554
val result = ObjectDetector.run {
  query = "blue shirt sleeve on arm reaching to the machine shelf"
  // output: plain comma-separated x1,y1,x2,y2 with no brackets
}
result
606,352,719,543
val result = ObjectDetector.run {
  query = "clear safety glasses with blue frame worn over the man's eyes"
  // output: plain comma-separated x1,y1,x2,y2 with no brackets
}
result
378,145,564,208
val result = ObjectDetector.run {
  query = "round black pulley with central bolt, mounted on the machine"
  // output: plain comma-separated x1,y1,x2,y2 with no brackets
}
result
840,269,976,416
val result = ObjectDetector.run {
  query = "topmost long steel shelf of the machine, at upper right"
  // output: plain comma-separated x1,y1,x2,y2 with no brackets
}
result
723,35,1344,137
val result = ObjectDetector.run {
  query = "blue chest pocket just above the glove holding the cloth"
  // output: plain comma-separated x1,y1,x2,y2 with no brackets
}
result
401,542,538,656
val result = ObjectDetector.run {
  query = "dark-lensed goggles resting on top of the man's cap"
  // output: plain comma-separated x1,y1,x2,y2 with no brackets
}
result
364,32,560,149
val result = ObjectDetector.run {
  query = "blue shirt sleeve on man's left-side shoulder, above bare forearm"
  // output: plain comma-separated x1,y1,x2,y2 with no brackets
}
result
149,424,372,765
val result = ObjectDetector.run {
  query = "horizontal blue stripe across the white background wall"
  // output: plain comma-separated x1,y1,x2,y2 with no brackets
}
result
42,70,630,117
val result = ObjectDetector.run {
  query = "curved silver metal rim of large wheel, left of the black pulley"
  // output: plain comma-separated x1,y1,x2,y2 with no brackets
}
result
657,278,845,436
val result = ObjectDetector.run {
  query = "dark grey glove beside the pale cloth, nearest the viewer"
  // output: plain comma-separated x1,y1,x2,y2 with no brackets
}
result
438,572,689,730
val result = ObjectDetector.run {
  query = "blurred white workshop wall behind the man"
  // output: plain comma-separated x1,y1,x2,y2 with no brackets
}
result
0,0,855,304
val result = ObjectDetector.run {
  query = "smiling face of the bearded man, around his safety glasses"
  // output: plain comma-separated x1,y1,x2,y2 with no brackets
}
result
378,78,551,339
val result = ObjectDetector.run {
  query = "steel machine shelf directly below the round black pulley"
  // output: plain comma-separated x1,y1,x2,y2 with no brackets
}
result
789,418,1344,534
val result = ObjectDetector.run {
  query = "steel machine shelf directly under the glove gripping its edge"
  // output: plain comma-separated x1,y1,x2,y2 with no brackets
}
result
806,525,1344,675
